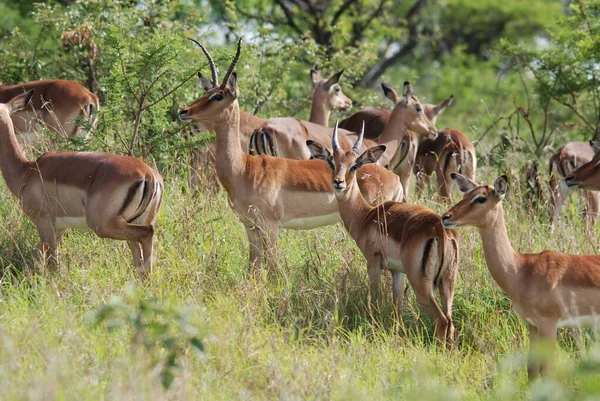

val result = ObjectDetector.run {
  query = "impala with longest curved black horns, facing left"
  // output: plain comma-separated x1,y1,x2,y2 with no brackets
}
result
179,40,402,270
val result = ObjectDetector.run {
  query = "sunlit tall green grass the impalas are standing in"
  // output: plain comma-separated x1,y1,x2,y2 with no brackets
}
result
0,159,600,400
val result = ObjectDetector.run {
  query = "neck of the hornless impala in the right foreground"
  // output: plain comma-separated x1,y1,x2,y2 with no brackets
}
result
479,204,519,297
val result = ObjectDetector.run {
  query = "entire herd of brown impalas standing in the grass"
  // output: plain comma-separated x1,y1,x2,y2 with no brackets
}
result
0,40,600,378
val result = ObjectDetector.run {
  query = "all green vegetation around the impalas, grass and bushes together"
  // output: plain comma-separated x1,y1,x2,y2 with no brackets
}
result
0,0,600,400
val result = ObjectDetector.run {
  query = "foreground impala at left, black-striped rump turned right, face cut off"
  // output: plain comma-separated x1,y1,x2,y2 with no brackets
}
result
0,89,163,278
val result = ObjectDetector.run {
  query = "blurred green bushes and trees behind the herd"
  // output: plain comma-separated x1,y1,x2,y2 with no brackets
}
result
0,0,600,176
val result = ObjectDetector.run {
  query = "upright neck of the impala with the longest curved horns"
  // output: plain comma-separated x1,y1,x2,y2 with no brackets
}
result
212,99,244,178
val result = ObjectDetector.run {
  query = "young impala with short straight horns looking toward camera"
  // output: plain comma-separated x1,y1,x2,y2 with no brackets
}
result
307,123,458,344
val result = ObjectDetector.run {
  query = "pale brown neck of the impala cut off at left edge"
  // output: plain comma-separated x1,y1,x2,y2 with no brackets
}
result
0,111,30,197
